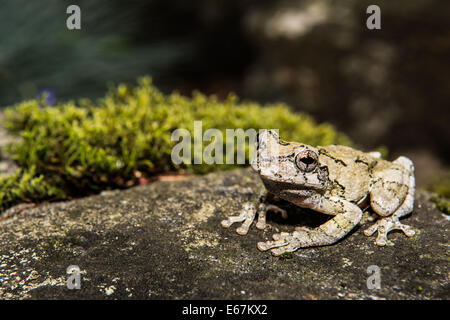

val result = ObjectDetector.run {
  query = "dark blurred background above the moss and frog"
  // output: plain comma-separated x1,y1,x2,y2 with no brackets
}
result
0,0,450,184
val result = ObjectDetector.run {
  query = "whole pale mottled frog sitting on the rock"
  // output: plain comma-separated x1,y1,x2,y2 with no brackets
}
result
222,130,415,255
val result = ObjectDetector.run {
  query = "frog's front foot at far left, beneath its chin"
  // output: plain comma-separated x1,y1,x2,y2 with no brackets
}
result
221,203,287,235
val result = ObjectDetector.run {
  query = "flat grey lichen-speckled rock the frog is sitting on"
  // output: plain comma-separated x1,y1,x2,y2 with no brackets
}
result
0,169,450,299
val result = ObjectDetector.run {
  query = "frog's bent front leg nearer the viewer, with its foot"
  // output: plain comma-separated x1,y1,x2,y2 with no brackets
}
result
258,197,363,256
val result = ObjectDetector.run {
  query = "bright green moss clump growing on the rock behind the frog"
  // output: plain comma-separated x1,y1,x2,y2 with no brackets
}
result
1,78,350,208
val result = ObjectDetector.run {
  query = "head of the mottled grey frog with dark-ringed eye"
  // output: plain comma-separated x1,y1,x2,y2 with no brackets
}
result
251,130,328,198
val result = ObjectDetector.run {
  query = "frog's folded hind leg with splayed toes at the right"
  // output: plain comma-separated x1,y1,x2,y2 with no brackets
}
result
364,157,415,246
